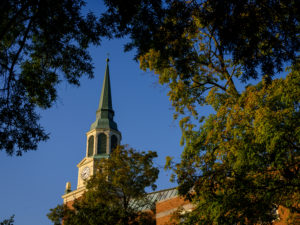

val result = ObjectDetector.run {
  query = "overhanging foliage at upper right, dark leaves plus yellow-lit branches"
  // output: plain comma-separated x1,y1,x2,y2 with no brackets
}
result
101,0,300,123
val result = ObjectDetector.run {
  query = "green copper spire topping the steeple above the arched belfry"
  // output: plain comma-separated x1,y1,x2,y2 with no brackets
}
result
91,59,118,130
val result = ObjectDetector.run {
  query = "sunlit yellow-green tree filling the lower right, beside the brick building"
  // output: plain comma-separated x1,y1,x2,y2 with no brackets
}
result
171,69,300,224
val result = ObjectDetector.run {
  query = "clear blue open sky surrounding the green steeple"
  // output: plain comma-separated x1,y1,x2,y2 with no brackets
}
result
0,29,188,225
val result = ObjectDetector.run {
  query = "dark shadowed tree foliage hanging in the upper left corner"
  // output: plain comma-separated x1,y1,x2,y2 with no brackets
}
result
0,0,102,155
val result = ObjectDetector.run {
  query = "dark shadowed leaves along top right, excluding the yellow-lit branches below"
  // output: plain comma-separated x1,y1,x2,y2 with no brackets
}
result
102,0,300,80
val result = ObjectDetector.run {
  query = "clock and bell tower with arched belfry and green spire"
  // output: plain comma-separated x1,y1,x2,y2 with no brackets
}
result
62,59,122,202
